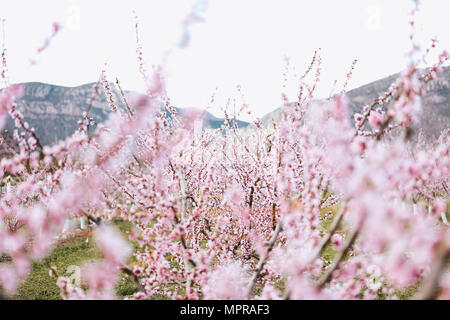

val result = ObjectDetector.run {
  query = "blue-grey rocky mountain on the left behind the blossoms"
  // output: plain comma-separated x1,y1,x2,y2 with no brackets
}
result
2,82,248,149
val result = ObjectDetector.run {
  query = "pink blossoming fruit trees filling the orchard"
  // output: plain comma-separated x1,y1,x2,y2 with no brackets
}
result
0,0,450,299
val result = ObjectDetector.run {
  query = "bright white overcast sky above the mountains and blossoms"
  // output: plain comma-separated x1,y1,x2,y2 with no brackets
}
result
0,0,450,119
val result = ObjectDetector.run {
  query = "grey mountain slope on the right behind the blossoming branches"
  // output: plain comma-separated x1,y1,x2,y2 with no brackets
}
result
262,67,450,140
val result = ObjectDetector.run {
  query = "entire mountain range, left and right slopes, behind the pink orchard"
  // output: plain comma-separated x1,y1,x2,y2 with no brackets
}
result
0,67,450,155
